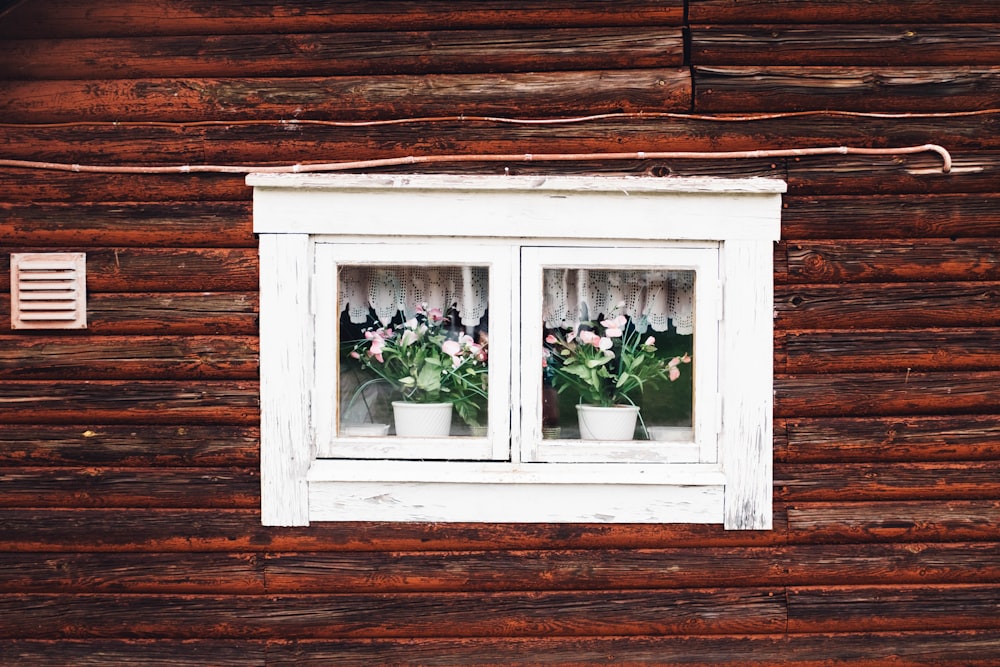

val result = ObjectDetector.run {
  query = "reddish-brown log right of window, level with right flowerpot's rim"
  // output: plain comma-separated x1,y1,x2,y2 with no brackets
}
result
774,371,1000,417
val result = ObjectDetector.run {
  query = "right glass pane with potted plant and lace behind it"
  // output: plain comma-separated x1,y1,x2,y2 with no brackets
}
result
541,268,695,441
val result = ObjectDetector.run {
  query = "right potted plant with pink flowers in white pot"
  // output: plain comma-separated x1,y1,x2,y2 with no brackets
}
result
543,305,691,440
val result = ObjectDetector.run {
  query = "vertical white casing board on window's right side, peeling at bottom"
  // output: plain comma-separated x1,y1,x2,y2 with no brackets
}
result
720,241,774,530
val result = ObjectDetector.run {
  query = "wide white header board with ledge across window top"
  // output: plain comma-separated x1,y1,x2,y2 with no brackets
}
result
247,174,784,240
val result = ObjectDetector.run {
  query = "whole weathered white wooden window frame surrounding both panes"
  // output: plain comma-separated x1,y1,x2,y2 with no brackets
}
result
247,174,785,529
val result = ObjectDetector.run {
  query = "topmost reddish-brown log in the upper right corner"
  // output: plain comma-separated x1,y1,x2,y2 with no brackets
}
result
689,0,997,23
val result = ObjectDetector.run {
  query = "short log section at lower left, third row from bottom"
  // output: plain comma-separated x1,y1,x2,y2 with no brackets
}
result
0,553,265,595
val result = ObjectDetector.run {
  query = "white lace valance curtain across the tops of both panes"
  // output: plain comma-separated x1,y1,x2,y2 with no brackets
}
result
340,266,694,334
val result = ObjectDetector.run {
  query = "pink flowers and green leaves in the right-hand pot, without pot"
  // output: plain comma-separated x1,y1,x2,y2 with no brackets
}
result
543,309,691,407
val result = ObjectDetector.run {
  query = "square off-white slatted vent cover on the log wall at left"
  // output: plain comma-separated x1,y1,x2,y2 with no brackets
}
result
10,252,87,329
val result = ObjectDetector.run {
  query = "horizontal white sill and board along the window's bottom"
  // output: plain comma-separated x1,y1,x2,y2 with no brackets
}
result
310,461,723,523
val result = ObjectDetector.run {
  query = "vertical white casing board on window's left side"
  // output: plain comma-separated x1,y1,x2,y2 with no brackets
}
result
260,235,314,526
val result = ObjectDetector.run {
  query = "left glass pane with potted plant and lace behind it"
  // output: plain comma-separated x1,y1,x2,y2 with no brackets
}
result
338,264,489,437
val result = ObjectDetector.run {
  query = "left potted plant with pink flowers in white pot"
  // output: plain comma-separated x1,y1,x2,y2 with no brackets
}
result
350,304,489,436
